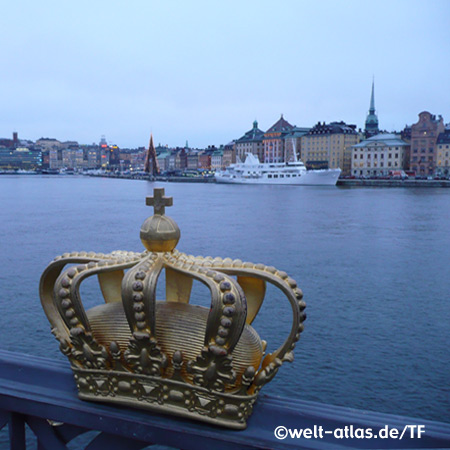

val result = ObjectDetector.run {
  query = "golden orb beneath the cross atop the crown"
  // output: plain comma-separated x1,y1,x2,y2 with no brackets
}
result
141,214,180,252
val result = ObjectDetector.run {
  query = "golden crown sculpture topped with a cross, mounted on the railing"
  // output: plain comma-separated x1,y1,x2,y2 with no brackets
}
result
40,189,306,429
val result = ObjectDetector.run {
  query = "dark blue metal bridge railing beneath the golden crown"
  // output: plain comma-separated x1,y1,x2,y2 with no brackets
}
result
0,350,450,450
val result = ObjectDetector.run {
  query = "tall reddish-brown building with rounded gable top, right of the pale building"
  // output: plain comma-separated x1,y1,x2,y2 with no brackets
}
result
410,111,445,176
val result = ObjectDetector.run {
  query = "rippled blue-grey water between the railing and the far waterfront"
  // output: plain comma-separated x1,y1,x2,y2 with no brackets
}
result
0,176,450,422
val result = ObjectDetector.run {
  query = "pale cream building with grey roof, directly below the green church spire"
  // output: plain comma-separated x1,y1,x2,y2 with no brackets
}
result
351,133,410,177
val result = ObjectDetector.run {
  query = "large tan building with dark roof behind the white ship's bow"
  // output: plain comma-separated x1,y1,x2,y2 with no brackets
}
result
301,121,360,175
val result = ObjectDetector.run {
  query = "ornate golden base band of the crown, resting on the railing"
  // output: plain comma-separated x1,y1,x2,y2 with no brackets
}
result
72,367,257,430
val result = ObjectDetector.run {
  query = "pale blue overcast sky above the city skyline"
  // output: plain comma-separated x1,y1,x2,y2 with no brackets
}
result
0,0,450,147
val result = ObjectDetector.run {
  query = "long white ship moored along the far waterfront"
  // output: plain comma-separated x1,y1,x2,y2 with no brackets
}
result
215,153,341,186
